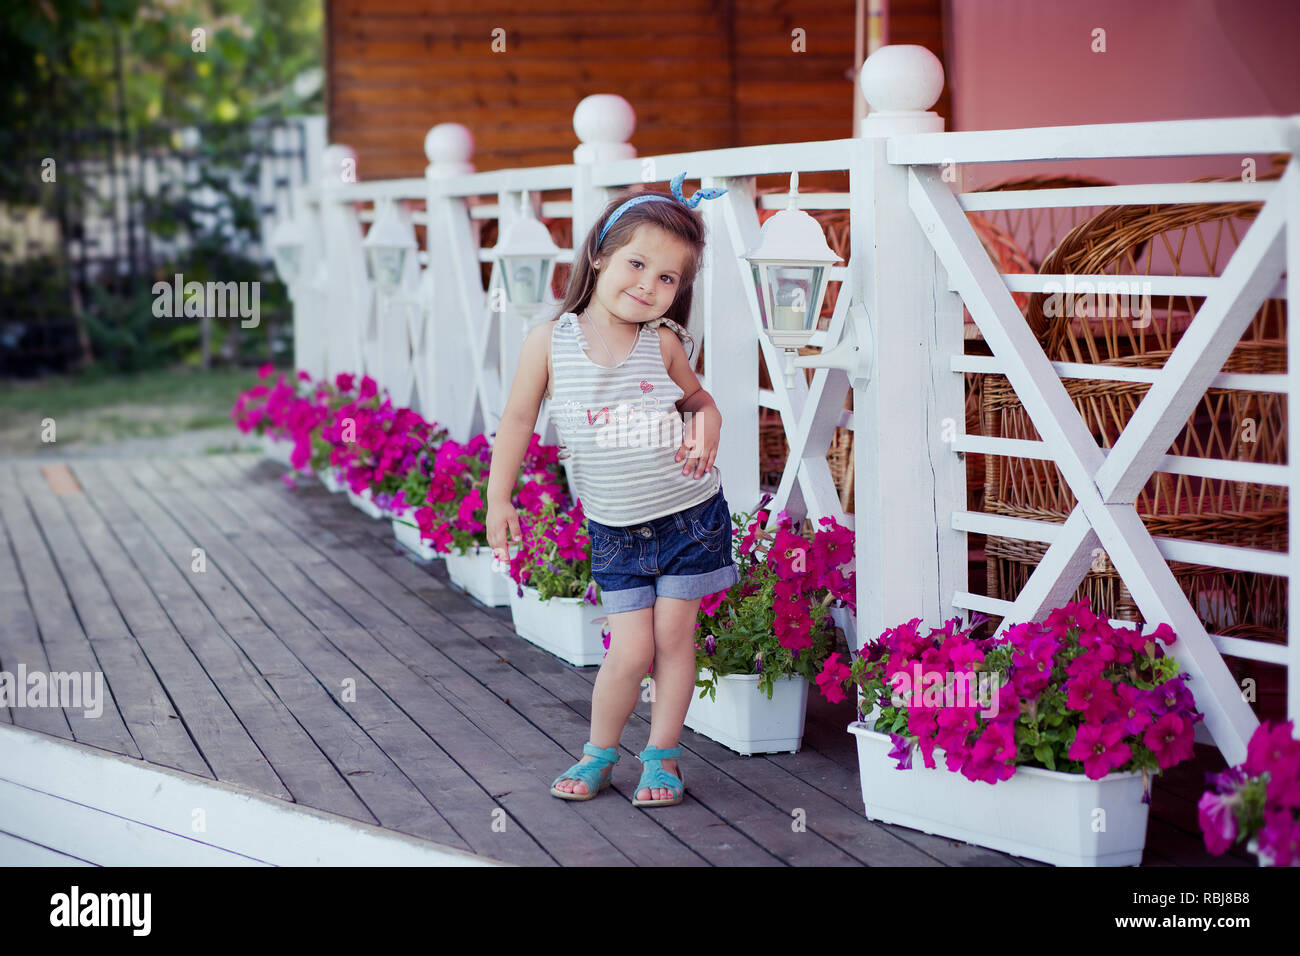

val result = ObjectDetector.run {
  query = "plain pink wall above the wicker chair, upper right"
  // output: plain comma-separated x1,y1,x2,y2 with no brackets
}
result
945,0,1300,189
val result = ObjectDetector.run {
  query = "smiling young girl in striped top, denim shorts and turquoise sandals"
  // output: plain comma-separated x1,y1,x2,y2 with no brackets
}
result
488,173,740,806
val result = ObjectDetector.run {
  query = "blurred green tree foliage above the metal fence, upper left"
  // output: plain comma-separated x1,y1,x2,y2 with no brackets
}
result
0,0,324,143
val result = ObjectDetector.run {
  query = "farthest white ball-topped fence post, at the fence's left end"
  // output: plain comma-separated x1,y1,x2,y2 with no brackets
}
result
320,144,372,376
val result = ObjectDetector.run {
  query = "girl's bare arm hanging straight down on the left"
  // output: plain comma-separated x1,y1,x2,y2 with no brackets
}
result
486,323,555,561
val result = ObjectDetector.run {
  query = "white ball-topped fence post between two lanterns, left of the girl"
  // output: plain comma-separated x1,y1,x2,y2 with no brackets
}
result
416,122,484,441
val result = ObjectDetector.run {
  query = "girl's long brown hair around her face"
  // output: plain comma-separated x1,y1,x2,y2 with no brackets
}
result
553,190,705,348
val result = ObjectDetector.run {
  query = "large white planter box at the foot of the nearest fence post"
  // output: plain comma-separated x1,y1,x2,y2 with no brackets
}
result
849,714,1149,866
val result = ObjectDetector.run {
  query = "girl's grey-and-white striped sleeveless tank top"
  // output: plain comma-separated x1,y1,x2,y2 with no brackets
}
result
550,312,722,528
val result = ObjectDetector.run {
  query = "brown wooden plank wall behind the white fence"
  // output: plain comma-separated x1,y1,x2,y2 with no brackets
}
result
326,0,948,179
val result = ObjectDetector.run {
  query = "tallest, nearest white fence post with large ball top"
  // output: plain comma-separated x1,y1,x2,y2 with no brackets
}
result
850,47,967,649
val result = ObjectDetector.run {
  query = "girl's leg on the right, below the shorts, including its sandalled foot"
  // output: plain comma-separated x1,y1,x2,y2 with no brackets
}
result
637,597,699,800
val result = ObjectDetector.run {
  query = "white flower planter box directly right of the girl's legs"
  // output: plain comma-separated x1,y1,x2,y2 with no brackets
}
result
686,674,809,756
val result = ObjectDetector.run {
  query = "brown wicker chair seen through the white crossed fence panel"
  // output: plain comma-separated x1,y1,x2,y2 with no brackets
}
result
982,157,1287,640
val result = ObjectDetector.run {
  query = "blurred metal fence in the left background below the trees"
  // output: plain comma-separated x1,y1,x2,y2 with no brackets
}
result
0,117,324,375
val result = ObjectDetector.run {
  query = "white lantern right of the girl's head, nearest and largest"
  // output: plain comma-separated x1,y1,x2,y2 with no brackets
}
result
744,173,841,386
